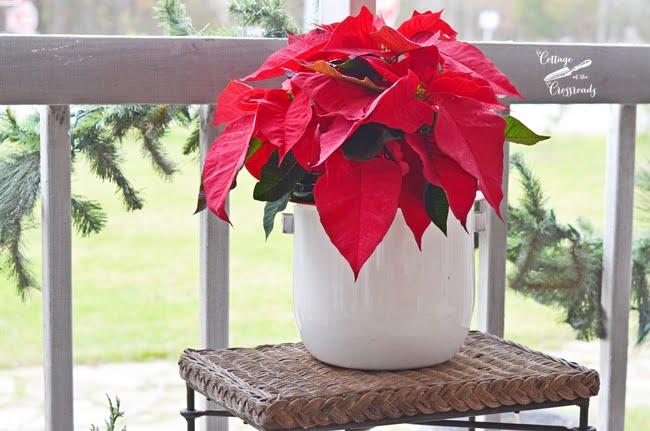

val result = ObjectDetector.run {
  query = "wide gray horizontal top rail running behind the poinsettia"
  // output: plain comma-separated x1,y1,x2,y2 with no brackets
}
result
0,35,650,105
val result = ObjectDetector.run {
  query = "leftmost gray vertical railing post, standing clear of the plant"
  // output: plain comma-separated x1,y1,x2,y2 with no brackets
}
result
41,106,74,431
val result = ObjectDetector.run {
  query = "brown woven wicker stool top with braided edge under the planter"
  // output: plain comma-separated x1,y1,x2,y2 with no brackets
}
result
179,332,599,430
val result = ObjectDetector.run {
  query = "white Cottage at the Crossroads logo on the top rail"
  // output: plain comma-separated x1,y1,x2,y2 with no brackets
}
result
537,49,596,98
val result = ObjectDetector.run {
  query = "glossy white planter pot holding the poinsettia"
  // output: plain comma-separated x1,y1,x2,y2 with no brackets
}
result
293,205,474,370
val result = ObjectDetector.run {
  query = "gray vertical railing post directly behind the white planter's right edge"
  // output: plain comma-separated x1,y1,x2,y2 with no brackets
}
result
477,142,510,337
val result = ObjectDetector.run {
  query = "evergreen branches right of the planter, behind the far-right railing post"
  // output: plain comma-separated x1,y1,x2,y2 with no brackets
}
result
507,155,650,343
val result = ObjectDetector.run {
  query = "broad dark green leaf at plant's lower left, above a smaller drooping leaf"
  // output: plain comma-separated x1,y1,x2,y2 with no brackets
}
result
253,151,307,202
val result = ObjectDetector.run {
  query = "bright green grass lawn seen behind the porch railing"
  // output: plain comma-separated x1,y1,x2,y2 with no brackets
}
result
0,127,649,368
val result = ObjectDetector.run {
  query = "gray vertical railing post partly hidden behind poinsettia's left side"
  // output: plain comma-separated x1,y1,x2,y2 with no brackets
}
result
199,105,230,431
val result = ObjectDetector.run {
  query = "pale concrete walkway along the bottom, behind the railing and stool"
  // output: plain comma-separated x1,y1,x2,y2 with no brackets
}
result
0,341,650,431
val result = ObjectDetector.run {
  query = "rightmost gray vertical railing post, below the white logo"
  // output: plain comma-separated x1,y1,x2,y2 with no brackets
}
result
598,105,636,431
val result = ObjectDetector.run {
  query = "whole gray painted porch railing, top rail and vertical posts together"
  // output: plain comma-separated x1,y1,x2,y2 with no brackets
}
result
0,4,650,431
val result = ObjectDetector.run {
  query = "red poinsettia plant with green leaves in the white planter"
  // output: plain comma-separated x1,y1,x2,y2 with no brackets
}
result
202,8,542,277
